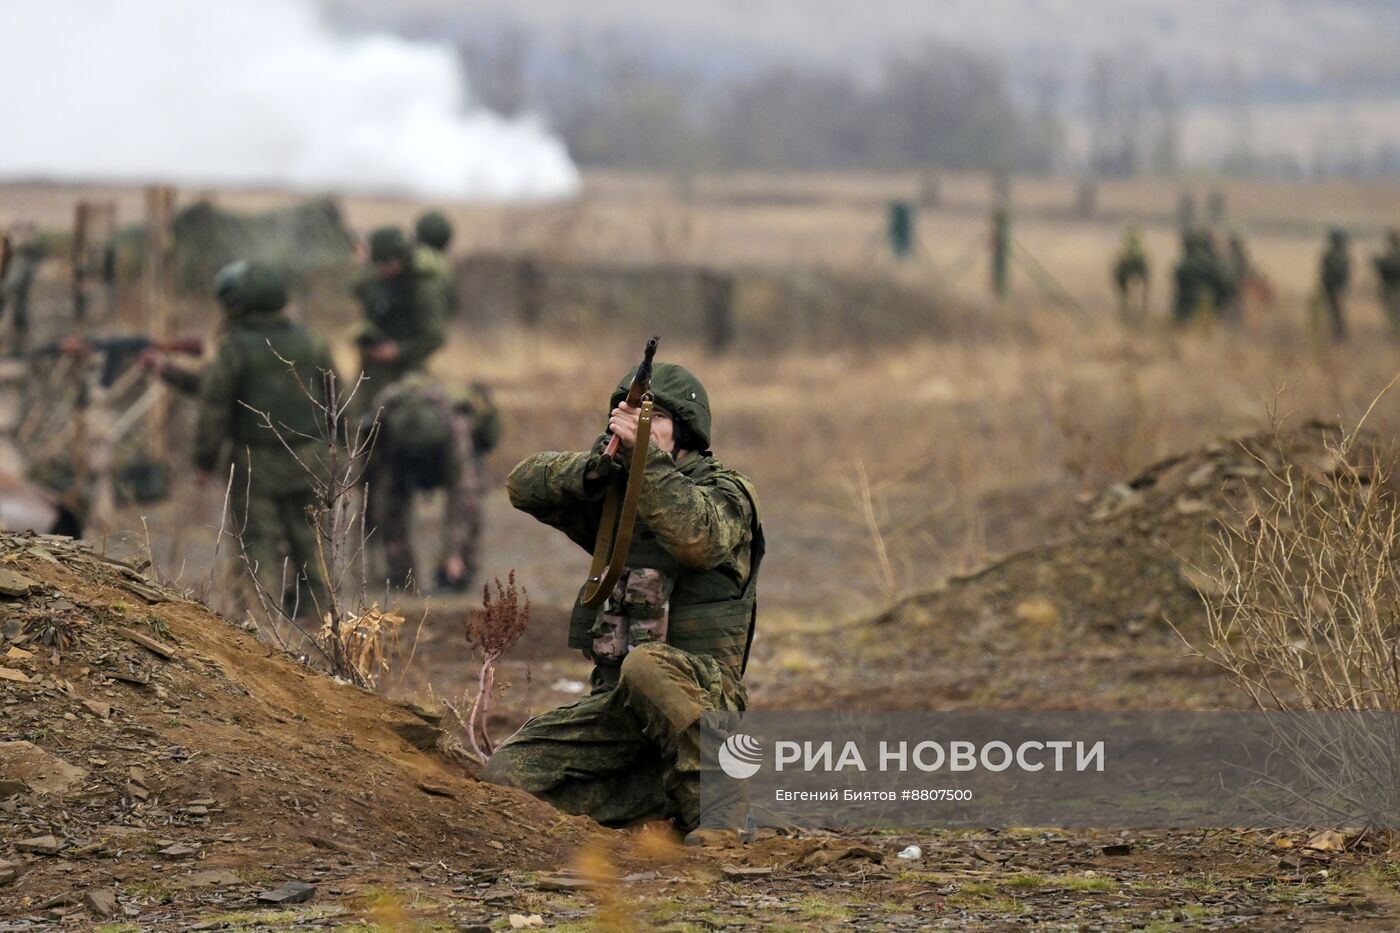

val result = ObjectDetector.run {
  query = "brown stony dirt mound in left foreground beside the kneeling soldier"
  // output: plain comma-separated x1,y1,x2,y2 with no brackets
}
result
0,535,598,926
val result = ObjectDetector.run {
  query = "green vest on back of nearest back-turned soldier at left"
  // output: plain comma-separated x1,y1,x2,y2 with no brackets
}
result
228,317,326,447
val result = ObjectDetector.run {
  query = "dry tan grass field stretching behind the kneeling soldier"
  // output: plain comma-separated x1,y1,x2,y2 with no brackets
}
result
8,175,1400,930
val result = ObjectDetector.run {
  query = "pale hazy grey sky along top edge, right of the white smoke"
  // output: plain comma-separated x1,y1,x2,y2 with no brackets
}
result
329,0,1400,90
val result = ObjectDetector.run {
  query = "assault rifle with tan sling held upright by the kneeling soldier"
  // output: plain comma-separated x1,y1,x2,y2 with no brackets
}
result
584,336,661,609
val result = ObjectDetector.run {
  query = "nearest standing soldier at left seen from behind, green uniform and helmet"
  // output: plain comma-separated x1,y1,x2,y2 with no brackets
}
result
195,262,333,616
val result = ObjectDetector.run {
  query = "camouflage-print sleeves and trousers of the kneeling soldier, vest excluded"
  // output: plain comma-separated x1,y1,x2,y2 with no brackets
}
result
483,424,762,829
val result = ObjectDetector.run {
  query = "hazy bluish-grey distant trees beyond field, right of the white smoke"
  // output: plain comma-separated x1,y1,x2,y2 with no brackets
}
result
459,35,1063,171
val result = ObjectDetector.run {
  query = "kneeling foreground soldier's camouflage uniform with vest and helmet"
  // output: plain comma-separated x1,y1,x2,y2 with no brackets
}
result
482,363,763,829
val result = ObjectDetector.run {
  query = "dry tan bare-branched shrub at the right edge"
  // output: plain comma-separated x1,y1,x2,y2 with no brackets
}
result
1200,417,1400,827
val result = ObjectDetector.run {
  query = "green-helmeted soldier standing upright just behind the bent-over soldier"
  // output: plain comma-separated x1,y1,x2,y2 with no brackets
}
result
354,227,447,410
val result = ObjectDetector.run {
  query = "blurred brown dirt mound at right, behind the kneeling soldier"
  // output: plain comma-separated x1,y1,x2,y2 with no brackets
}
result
875,423,1387,650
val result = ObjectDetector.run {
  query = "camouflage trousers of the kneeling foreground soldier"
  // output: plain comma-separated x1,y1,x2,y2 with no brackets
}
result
482,643,746,831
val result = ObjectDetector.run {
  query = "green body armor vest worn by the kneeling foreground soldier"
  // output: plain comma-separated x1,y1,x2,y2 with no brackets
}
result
568,461,764,677
